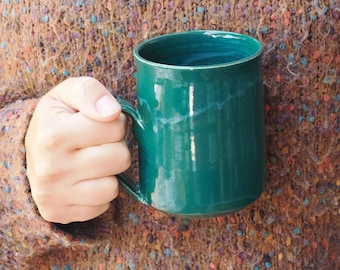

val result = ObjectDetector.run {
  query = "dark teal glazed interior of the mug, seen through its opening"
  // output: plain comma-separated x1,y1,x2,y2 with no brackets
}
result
135,31,262,67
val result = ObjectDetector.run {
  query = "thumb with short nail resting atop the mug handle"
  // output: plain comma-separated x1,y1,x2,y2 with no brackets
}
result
52,77,121,122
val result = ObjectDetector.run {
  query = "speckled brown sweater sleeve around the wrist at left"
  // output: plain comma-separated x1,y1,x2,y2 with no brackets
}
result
0,99,75,269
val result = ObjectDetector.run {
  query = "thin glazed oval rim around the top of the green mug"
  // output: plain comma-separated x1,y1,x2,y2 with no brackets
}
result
133,30,263,70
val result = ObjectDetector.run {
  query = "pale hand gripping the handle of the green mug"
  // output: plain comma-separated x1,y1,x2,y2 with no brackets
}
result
25,77,131,224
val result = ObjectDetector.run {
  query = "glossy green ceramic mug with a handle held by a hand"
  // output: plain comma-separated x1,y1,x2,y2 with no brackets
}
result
118,31,265,217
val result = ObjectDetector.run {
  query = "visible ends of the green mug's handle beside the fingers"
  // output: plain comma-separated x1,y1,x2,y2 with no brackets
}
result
116,97,144,202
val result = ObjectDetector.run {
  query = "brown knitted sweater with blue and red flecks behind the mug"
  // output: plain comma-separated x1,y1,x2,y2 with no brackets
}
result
0,0,340,270
